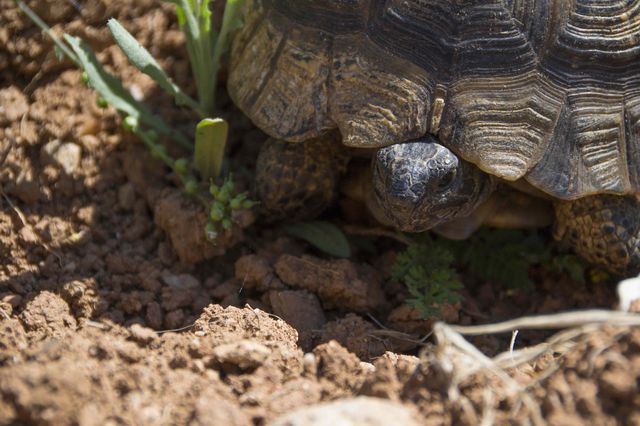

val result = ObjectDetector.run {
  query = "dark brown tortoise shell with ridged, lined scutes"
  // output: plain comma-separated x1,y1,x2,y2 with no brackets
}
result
228,0,640,199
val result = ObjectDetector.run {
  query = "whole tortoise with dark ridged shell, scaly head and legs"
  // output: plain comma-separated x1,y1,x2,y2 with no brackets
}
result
228,0,640,274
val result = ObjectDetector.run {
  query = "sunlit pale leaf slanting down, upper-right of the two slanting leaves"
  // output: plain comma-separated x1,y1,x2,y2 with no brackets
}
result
107,18,199,111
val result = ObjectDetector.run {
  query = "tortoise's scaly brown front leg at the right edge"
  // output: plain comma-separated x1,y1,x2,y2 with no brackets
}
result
555,195,640,276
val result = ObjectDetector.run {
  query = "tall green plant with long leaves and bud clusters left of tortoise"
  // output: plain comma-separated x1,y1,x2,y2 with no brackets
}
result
16,0,255,240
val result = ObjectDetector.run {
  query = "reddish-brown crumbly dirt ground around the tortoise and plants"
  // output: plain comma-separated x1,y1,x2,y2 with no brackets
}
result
0,0,640,425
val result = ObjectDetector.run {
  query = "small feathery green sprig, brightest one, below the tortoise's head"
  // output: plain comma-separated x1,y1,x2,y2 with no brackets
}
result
391,234,463,318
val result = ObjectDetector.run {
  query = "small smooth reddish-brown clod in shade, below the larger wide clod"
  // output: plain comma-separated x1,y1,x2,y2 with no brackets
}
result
269,290,327,332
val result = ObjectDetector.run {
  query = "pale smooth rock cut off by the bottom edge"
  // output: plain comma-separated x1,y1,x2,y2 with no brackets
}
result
269,396,424,426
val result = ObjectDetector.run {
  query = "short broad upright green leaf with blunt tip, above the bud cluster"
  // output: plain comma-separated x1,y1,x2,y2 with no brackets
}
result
193,118,229,181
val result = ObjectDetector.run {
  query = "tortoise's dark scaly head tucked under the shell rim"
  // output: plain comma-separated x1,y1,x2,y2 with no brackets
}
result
369,137,494,232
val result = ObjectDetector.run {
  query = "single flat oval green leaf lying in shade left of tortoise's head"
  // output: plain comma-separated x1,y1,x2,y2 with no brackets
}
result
284,221,351,257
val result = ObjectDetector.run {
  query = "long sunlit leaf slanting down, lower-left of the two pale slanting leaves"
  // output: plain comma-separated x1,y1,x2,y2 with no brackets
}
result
64,34,191,149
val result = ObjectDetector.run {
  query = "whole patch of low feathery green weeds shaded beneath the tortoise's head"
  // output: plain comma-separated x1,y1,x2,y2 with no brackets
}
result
392,228,585,317
